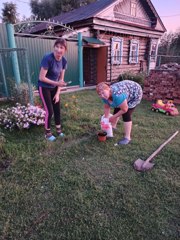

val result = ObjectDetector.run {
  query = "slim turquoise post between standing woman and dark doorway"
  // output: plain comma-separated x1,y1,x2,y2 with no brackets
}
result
78,33,84,87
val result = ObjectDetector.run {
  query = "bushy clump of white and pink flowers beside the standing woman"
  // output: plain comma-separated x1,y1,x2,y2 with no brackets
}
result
0,103,45,130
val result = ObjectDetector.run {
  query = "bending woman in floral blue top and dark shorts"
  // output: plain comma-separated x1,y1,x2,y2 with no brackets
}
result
96,80,142,144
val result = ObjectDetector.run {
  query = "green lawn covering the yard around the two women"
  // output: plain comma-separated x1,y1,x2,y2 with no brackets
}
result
0,90,180,240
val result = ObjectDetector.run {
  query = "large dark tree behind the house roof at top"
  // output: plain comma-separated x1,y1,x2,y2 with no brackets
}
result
30,0,96,19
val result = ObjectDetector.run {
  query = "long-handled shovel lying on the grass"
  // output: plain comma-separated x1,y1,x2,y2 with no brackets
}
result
134,131,179,172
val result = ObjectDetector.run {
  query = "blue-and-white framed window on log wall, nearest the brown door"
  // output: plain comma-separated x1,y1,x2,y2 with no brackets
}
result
111,37,123,64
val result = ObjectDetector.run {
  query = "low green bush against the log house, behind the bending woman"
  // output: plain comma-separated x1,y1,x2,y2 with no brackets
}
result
117,71,146,88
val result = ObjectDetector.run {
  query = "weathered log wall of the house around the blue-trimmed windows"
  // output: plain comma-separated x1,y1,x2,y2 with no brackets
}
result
99,34,150,81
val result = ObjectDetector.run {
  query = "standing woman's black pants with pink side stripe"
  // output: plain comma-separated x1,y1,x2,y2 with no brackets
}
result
39,87,61,129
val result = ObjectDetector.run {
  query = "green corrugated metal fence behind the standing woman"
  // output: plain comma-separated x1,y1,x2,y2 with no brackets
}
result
0,24,79,96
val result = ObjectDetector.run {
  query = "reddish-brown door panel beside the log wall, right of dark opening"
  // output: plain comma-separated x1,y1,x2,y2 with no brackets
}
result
96,47,107,83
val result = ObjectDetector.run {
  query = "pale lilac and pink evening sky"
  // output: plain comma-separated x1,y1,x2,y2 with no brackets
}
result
0,0,180,32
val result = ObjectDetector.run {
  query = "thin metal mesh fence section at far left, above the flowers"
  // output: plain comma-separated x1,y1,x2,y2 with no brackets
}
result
0,48,33,103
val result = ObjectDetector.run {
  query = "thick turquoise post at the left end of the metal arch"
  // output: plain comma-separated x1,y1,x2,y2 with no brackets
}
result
6,23,21,85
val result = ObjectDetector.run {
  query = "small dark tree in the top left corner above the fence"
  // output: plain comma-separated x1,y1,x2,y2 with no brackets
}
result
2,3,19,24
